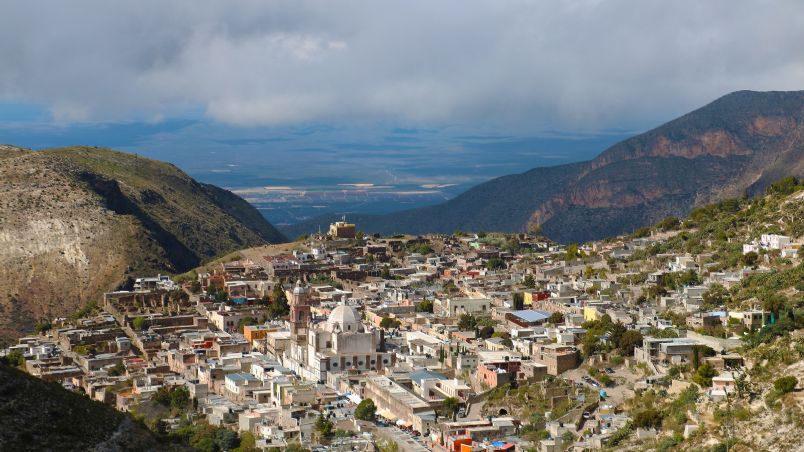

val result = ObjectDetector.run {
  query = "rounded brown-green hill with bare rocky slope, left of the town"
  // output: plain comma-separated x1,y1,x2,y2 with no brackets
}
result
0,146,285,337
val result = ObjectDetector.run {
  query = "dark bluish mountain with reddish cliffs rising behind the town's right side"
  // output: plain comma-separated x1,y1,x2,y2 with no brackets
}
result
283,91,804,242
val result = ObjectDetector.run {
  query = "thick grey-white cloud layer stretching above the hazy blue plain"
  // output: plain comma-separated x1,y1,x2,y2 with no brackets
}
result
0,0,804,130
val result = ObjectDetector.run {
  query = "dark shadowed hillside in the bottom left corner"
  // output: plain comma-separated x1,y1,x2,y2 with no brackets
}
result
0,364,173,451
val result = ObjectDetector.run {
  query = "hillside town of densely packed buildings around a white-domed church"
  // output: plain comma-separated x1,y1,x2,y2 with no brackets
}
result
0,185,804,452
